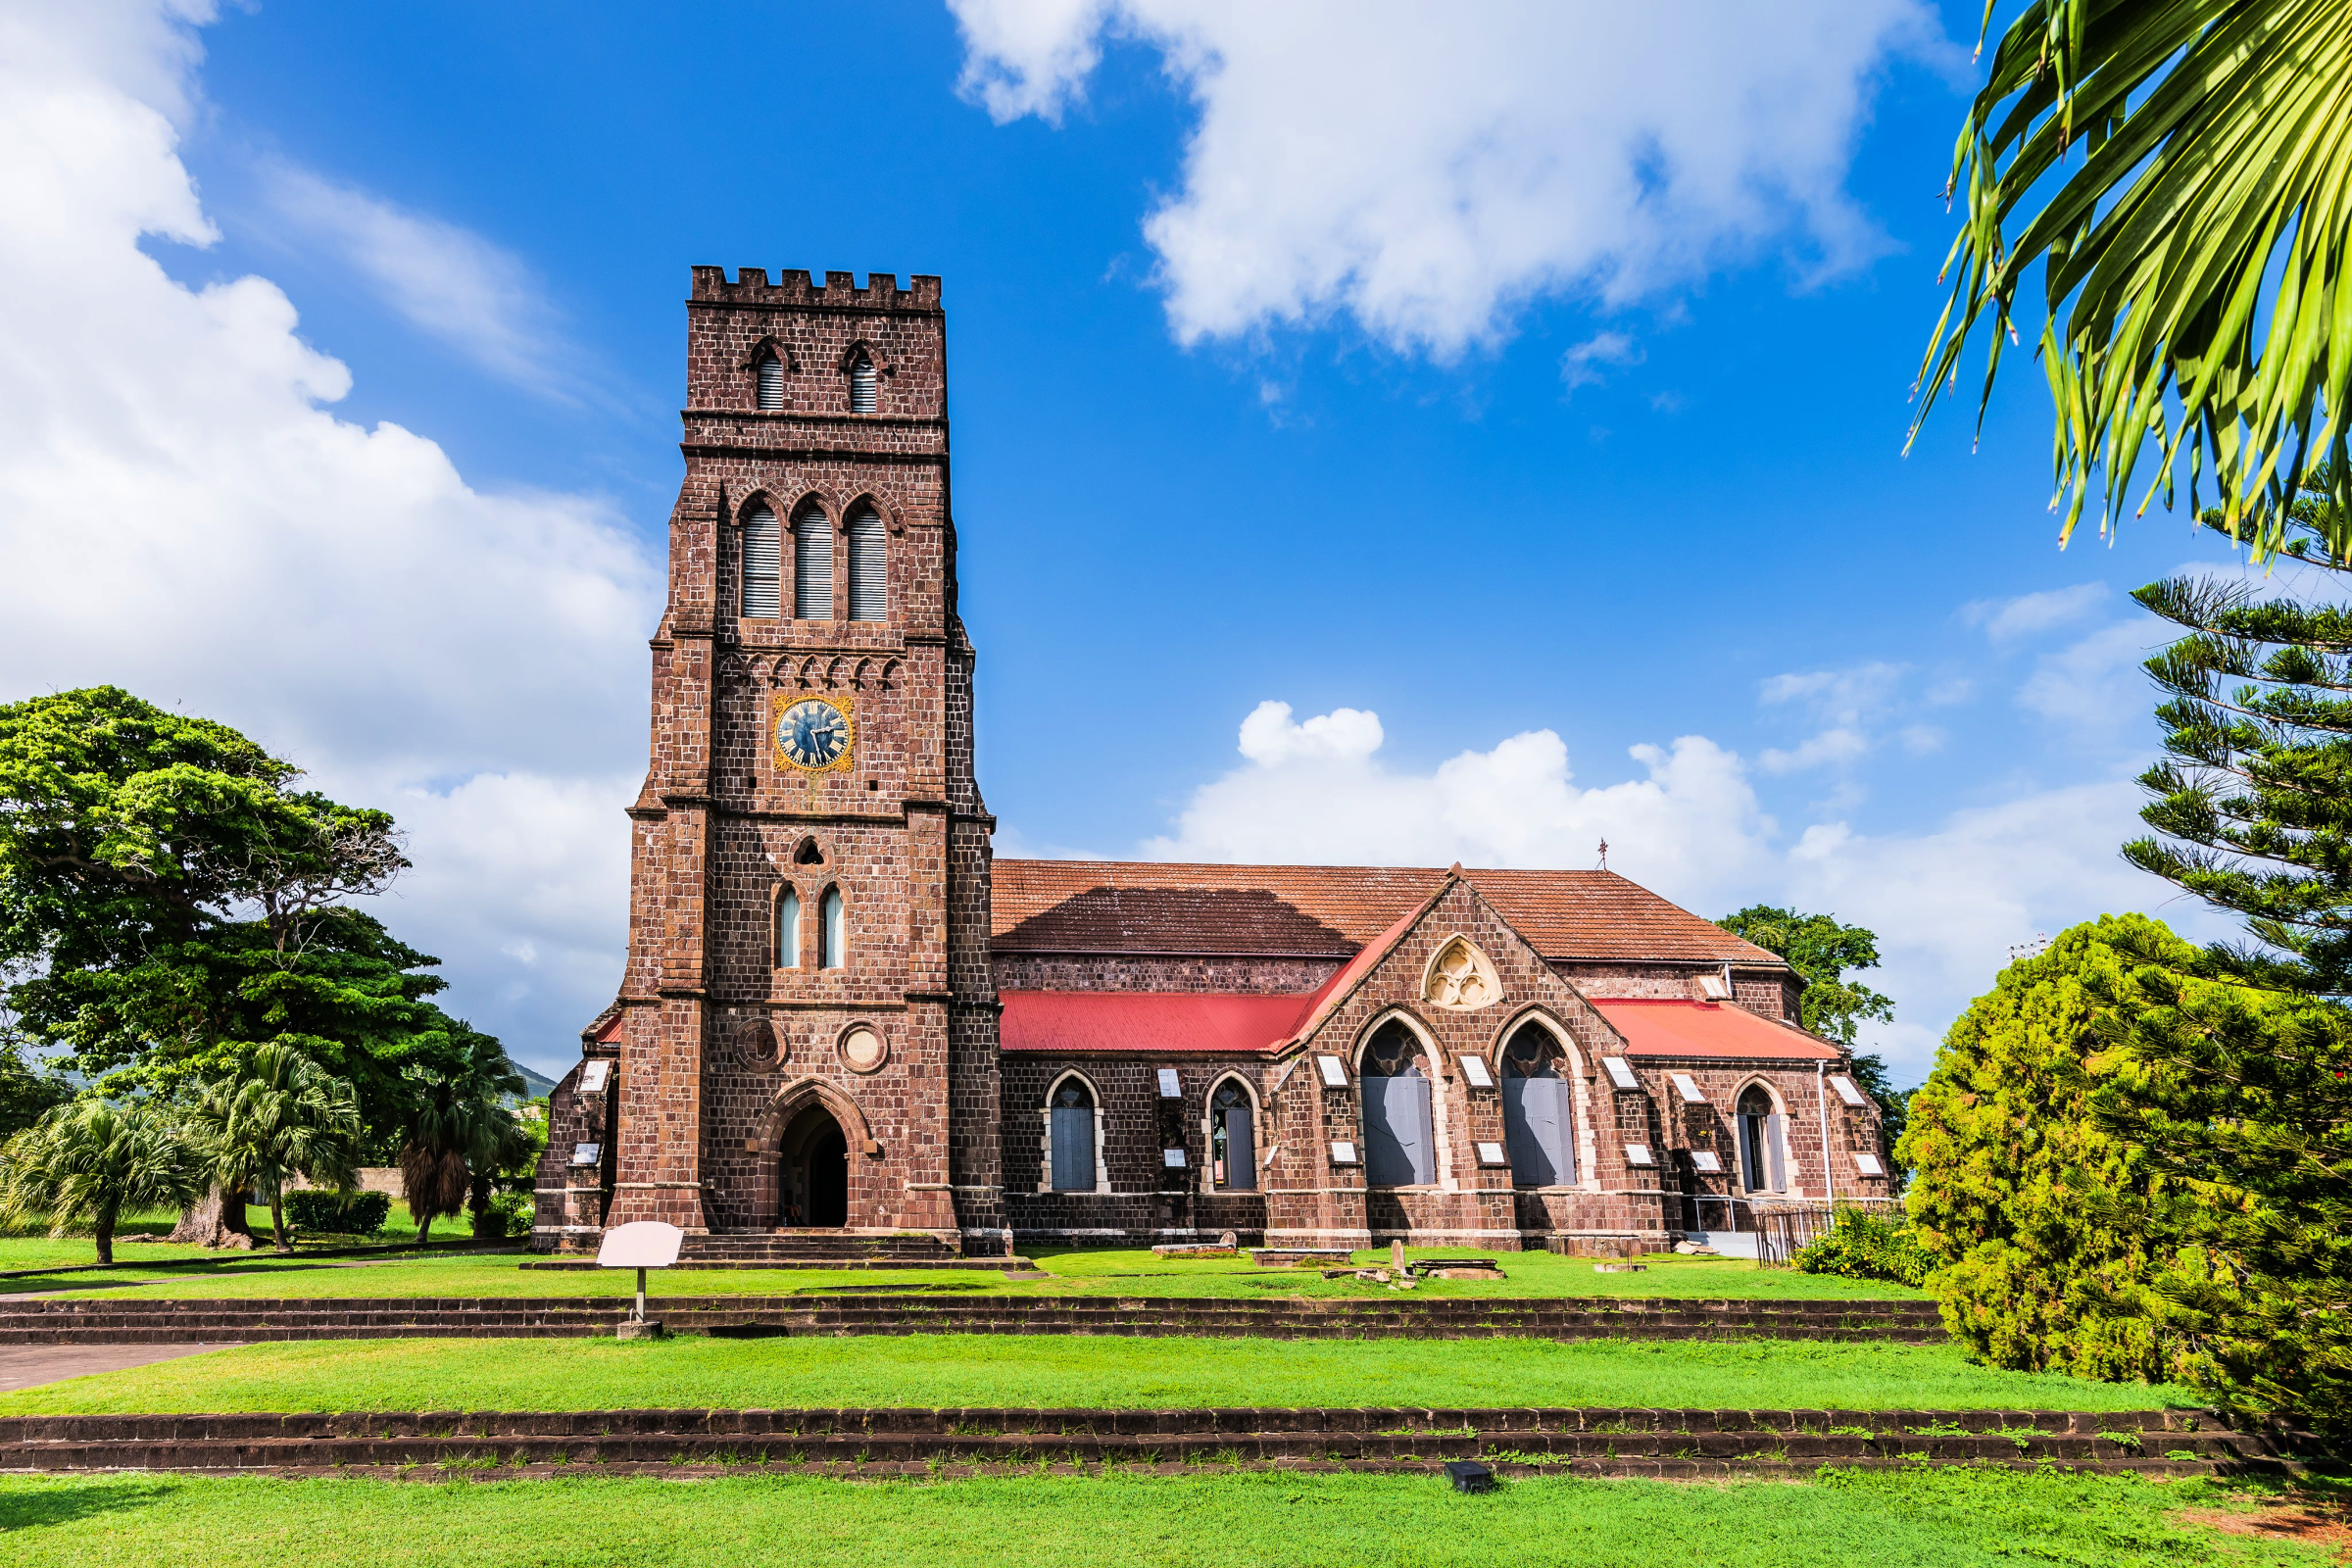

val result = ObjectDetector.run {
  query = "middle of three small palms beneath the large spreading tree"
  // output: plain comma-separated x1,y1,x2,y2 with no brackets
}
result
188,1044,365,1253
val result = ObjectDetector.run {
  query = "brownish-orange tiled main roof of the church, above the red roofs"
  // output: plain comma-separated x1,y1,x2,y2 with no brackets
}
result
993,860,1781,966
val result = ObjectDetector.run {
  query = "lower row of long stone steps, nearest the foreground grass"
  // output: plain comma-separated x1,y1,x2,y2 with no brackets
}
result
0,1408,2307,1481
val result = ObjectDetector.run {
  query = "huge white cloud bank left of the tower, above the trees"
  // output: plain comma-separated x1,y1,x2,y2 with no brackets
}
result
0,2,659,1065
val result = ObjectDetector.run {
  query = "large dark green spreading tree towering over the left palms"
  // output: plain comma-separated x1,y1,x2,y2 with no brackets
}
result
0,686,517,1242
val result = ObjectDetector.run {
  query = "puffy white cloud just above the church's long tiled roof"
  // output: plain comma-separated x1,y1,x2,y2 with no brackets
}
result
1141,703,1771,896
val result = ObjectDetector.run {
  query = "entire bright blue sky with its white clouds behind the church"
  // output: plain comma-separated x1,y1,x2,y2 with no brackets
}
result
0,0,2225,1079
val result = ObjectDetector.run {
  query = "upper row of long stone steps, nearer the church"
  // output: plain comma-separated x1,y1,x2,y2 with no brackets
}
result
0,1291,1945,1345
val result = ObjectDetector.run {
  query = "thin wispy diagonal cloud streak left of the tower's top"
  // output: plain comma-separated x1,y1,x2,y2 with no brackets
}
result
269,165,590,402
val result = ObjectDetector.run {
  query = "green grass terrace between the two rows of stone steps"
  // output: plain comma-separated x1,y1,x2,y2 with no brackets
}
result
0,1333,2197,1415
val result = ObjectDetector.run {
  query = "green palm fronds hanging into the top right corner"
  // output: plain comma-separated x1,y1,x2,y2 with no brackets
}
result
1912,0,2352,560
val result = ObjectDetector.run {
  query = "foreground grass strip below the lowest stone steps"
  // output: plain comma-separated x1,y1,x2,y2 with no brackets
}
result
0,1469,2328,1568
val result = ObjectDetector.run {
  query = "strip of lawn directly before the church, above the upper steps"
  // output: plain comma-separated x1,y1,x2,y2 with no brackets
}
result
0,1242,1924,1300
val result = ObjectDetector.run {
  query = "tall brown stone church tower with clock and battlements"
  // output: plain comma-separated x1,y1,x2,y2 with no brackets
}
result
600,268,1006,1253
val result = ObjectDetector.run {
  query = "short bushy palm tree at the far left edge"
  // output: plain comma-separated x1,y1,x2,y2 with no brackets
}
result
0,1098,205,1265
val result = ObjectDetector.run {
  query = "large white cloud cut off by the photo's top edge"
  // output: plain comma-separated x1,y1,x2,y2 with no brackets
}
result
948,0,1957,358
